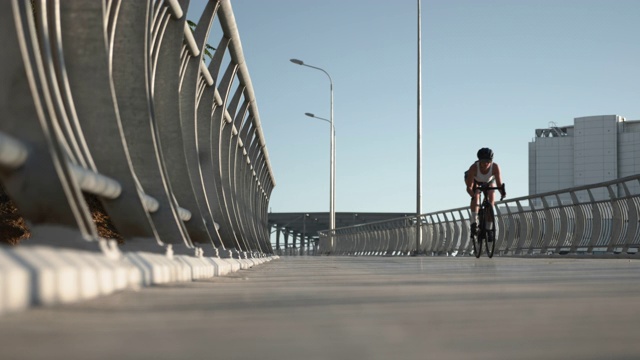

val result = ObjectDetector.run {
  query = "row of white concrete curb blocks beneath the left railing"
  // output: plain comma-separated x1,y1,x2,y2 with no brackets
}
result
0,246,278,314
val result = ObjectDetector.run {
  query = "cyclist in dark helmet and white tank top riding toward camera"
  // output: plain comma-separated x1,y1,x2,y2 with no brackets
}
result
464,148,507,236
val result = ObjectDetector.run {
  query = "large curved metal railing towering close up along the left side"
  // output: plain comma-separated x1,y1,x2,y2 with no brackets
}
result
0,0,275,256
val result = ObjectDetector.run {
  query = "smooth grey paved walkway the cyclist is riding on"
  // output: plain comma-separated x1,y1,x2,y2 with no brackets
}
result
0,257,640,360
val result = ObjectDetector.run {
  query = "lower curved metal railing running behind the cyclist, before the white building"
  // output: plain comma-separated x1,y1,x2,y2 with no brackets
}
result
319,175,640,256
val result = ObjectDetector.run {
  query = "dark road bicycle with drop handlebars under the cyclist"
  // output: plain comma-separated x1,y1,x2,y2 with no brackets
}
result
471,182,505,258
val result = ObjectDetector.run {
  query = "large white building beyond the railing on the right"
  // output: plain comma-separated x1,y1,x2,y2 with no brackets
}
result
529,115,640,202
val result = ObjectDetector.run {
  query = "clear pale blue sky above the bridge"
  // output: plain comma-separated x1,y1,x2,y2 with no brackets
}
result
188,0,640,217
